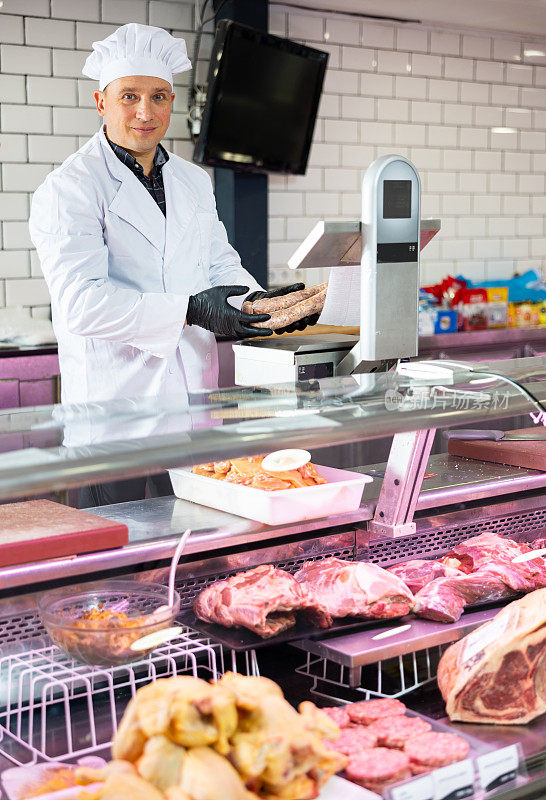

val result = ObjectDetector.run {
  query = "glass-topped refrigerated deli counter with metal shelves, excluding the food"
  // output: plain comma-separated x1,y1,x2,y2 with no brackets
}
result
0,357,546,800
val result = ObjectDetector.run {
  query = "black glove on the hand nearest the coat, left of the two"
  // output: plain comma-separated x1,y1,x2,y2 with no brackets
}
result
186,286,273,339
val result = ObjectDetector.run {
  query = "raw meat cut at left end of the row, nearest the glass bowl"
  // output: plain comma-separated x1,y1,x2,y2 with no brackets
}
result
193,564,316,639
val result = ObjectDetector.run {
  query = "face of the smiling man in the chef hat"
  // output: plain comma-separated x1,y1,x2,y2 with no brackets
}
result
95,75,174,157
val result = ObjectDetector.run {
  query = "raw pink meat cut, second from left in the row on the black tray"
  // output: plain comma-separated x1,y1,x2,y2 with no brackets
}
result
295,557,413,627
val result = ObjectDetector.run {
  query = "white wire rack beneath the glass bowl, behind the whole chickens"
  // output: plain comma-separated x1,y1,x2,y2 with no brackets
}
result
0,628,224,766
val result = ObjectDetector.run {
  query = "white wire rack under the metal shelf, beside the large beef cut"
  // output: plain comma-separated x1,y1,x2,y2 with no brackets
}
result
296,645,448,702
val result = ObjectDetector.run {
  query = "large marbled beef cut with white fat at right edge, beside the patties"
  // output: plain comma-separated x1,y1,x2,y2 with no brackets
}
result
438,589,546,725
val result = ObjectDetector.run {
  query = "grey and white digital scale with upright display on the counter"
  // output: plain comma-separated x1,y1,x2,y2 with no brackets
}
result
233,155,440,386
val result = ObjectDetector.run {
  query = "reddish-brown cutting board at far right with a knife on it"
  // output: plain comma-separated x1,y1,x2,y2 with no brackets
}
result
448,428,546,472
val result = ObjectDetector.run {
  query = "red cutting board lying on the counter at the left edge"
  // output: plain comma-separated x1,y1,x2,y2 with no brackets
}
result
0,500,129,567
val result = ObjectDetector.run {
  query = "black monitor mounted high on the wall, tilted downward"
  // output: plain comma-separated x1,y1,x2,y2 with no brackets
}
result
194,20,328,175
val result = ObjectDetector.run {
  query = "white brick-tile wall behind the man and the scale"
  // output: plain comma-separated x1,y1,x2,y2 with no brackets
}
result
0,0,546,314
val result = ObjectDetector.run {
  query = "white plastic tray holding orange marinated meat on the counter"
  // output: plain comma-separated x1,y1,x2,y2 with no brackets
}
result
169,465,373,525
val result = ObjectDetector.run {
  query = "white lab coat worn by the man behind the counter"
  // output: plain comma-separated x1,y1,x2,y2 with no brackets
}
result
30,129,260,410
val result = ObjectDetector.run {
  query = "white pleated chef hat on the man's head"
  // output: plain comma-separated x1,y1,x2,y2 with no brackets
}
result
82,22,191,91
